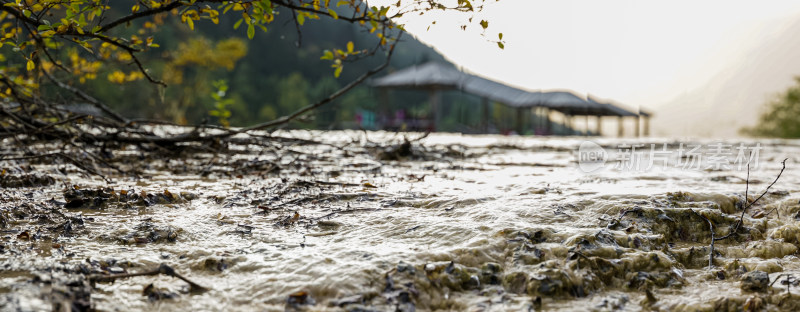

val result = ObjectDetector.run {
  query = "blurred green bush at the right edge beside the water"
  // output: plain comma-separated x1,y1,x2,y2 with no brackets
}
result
741,77,800,138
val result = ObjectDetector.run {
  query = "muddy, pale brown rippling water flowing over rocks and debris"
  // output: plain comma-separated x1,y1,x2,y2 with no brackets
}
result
0,132,800,311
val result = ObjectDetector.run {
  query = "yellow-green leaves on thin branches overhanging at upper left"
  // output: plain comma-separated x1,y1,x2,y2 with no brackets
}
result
0,0,502,111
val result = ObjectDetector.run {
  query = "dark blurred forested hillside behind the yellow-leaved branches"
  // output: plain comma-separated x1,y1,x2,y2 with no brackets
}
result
78,6,444,129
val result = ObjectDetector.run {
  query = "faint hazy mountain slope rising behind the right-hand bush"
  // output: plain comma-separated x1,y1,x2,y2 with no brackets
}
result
652,18,800,137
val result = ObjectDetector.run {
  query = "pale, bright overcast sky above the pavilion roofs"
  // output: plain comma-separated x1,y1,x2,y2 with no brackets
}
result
396,0,800,111
